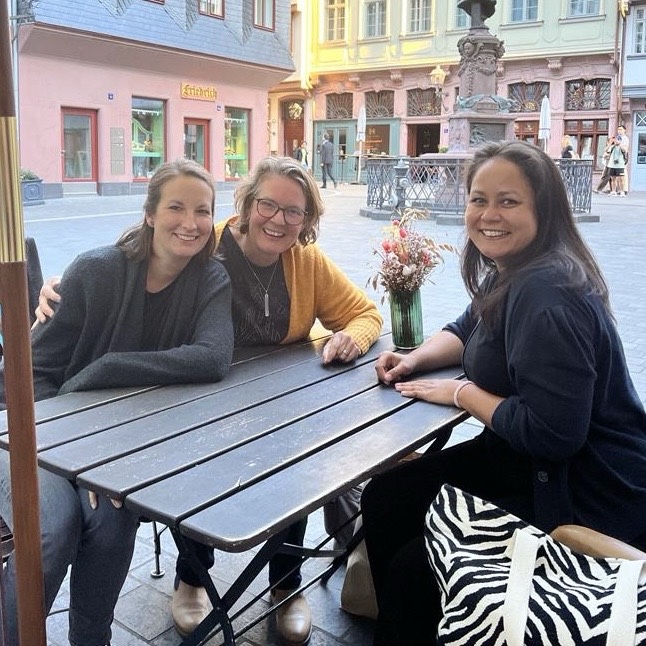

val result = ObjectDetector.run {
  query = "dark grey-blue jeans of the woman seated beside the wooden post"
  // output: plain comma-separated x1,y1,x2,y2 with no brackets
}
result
0,451,139,646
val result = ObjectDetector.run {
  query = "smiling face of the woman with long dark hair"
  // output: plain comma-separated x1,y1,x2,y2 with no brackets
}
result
464,157,538,270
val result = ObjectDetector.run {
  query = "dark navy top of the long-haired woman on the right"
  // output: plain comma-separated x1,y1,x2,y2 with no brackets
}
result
446,267,646,549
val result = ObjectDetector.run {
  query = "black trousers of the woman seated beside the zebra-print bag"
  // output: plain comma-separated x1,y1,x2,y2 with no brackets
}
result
361,434,534,646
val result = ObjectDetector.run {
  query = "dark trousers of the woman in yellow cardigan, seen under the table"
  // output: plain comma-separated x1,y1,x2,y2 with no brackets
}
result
175,518,307,590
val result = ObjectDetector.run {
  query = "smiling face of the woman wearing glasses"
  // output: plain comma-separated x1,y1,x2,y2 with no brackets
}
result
238,175,307,266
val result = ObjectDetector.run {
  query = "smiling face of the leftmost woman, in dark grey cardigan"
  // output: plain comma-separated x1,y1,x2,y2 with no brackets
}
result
146,175,213,270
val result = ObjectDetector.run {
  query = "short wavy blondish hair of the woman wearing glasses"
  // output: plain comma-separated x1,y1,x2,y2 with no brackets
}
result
234,156,324,245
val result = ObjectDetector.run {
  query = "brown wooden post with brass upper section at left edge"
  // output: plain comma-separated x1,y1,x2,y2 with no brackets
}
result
0,1,46,646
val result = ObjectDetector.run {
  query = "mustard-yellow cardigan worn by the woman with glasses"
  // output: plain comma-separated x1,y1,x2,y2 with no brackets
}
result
215,216,383,354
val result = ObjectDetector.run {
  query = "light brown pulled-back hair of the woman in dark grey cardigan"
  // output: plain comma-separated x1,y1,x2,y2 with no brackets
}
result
117,159,215,262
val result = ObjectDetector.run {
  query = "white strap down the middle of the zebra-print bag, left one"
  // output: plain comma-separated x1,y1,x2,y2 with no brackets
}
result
502,529,539,646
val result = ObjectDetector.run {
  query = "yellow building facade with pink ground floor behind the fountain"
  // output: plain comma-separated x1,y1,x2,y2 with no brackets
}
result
268,0,627,181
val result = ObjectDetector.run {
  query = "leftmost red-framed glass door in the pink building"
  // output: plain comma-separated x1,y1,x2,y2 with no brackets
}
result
61,108,97,182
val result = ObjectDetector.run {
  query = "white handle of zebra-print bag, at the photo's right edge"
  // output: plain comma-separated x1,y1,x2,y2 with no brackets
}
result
606,560,646,646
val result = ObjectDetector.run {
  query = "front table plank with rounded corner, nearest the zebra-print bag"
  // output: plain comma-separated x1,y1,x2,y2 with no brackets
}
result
180,402,467,552
